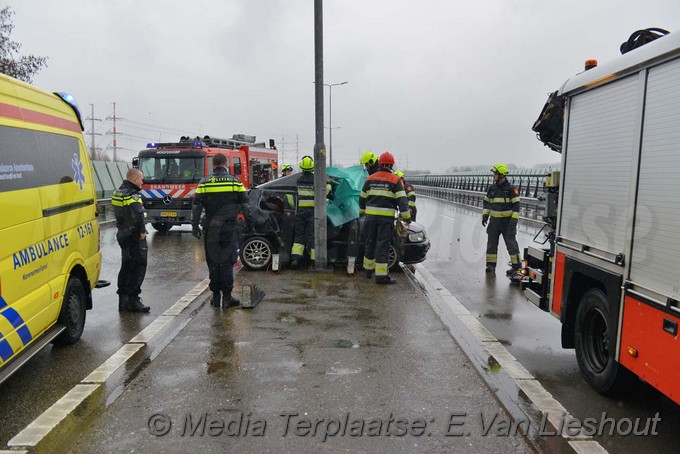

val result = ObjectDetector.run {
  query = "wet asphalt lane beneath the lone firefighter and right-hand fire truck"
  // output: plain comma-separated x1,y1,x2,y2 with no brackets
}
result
418,198,680,453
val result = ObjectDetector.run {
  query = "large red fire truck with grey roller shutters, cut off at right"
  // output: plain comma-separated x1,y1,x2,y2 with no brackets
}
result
522,33,680,403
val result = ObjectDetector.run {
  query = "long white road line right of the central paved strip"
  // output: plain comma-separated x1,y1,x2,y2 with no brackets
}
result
413,263,607,448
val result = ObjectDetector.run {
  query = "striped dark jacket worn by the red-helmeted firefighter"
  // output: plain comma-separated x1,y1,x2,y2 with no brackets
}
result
359,168,411,220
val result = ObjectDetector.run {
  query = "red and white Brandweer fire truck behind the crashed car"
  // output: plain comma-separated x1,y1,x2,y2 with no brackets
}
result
133,134,278,232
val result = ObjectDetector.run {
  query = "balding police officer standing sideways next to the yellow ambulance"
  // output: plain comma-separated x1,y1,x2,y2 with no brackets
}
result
111,169,150,312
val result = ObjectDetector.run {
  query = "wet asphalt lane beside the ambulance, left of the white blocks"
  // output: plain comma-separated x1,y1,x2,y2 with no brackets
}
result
0,225,206,449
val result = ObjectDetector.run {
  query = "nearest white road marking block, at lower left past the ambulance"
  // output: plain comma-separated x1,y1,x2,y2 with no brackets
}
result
7,384,101,447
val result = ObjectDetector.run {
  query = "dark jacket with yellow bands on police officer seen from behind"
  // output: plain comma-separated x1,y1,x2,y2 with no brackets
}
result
191,167,250,227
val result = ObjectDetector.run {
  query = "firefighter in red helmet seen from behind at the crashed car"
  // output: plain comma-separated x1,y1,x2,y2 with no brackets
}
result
359,151,411,284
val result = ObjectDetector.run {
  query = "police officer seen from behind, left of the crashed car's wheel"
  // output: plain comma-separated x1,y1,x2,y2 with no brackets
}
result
191,153,250,307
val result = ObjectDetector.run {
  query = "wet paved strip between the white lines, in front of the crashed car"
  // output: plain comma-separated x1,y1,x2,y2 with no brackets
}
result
71,270,532,454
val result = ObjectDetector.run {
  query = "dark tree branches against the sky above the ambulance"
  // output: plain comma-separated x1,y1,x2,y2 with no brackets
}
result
0,6,47,83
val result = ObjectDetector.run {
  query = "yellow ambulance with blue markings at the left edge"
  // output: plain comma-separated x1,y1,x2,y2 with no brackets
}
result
0,74,107,383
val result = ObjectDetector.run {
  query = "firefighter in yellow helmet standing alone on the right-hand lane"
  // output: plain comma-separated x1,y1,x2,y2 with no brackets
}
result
482,163,520,276
